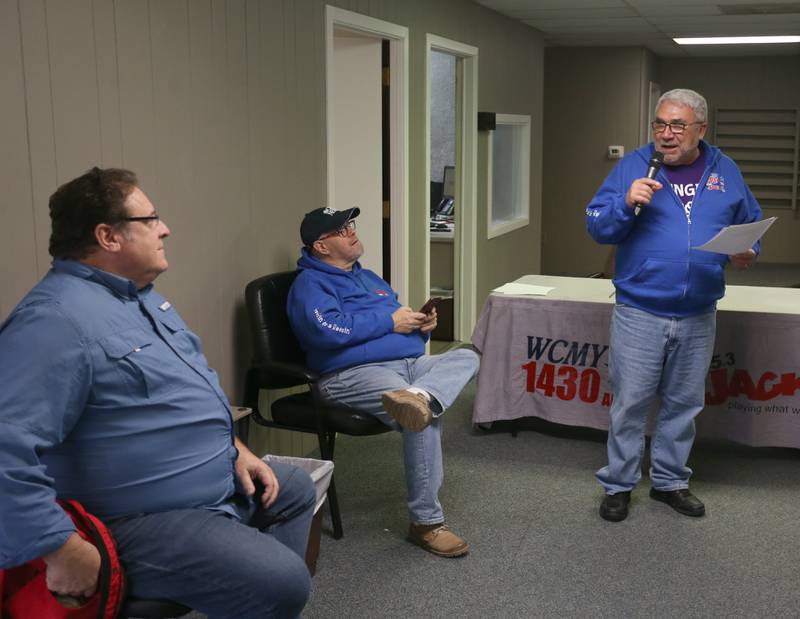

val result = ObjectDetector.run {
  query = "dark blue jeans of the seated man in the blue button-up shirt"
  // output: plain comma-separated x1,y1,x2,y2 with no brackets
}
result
107,462,315,619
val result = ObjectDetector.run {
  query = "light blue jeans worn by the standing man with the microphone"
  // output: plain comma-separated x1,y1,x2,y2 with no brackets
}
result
597,305,716,494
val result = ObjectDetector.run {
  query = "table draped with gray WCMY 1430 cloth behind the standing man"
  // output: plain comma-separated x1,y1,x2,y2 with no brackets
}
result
472,275,800,448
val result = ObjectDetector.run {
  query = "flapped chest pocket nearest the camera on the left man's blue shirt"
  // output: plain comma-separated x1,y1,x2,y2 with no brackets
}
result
99,328,182,399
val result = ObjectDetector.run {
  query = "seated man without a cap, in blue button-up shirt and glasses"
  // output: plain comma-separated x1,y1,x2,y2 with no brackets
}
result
0,168,314,617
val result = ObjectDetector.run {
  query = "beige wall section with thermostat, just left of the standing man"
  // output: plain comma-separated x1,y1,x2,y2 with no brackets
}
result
542,48,652,276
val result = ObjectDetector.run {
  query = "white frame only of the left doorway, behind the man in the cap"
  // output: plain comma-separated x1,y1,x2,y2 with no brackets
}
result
325,5,409,303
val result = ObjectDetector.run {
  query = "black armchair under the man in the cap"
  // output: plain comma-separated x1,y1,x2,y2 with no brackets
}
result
244,271,391,539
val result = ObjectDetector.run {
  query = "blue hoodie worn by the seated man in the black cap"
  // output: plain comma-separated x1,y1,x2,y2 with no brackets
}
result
286,247,427,374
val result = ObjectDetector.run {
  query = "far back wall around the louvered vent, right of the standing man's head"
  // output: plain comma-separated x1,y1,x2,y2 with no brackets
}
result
657,56,800,263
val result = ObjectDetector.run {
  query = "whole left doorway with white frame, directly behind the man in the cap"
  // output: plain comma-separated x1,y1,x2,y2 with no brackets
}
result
325,6,408,299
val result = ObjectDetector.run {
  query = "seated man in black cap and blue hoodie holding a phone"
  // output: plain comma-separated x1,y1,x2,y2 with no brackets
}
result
287,208,478,557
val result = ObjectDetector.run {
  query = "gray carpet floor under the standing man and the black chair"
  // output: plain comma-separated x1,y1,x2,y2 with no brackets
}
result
304,385,800,618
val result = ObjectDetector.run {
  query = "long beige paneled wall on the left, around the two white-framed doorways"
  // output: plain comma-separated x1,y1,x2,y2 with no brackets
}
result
0,0,543,450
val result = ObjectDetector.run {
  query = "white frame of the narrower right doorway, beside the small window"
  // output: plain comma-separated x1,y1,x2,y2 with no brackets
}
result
425,33,478,342
